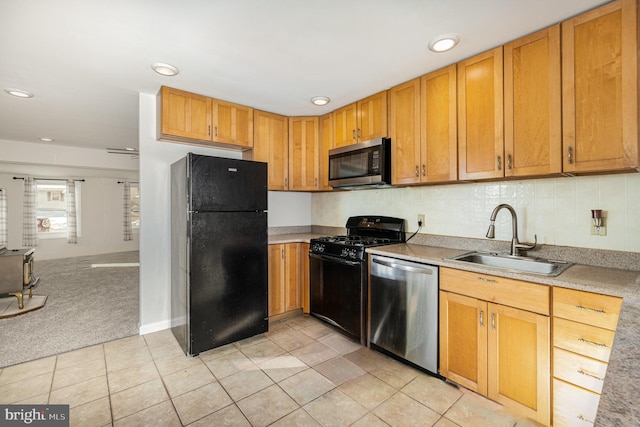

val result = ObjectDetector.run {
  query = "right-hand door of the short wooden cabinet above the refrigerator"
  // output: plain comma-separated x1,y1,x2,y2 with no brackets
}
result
211,99,253,148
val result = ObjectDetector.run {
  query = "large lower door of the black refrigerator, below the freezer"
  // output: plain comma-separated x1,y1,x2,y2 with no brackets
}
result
189,212,268,355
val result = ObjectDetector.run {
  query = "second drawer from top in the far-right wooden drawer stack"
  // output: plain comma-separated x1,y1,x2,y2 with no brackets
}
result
553,317,615,362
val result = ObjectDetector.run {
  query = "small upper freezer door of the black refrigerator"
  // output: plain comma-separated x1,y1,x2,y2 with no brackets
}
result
188,153,267,212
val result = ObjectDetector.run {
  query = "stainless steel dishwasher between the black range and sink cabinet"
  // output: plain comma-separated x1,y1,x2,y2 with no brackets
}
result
369,255,438,374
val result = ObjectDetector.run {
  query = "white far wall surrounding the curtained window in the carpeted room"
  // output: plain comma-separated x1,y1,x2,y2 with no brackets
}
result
0,140,138,260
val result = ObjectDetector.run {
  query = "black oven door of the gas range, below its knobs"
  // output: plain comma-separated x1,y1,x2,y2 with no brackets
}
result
309,254,366,343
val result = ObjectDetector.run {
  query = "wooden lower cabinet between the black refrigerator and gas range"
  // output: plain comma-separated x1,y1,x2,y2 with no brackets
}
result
269,243,304,320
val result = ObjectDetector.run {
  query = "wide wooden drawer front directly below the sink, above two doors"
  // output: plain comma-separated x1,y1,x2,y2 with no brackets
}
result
440,267,550,316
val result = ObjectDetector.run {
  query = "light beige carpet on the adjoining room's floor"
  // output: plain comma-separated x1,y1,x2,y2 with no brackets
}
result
0,250,140,367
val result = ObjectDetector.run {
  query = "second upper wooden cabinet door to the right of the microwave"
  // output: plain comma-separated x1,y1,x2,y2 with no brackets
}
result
420,64,458,182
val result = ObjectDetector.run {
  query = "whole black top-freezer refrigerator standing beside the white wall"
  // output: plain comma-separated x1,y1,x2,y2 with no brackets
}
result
171,153,269,355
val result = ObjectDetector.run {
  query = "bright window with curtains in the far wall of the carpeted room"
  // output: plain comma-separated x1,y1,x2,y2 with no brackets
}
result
36,180,80,238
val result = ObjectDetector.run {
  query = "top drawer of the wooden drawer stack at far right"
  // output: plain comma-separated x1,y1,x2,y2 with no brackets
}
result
553,287,622,331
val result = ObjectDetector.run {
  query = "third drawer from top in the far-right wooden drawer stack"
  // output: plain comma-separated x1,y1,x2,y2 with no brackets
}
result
553,348,607,394
